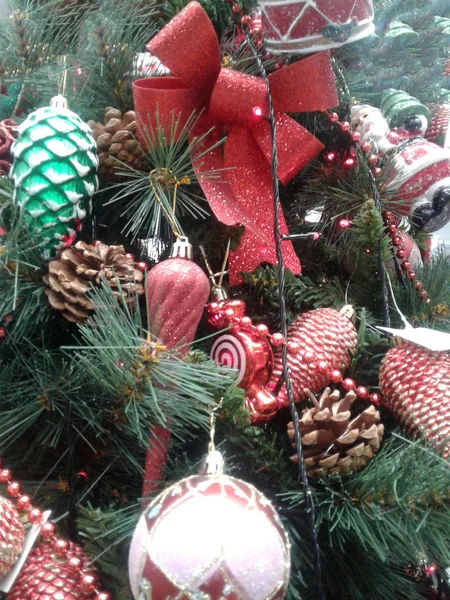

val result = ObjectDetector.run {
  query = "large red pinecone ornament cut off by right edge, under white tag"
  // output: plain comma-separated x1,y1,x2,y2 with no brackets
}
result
380,343,450,458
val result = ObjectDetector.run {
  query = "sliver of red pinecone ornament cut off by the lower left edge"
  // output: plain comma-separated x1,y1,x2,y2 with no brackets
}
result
0,496,24,578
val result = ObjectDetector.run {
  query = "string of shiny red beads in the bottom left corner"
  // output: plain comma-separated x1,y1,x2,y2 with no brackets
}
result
0,459,111,600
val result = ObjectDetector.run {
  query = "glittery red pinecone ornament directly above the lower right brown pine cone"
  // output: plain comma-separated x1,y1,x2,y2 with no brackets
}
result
266,306,357,406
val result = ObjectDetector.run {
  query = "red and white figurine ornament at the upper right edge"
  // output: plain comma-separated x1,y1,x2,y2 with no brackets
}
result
352,105,450,233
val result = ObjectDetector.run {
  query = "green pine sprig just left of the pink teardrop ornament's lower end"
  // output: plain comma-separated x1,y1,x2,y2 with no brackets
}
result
63,286,243,472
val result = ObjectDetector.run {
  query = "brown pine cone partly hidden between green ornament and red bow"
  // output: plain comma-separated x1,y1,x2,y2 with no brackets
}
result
88,106,144,182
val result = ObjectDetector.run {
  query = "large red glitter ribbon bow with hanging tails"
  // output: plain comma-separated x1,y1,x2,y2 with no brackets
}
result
134,2,338,284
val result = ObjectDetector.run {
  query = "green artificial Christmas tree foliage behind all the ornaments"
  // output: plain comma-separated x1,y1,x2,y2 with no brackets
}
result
0,0,450,600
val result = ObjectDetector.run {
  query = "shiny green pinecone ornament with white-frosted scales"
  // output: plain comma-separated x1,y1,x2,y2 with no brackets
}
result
10,96,98,260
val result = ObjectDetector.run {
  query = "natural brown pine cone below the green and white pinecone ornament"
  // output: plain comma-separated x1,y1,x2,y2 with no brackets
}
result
44,242,144,323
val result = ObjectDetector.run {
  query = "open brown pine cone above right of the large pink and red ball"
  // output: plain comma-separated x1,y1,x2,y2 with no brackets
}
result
288,388,384,477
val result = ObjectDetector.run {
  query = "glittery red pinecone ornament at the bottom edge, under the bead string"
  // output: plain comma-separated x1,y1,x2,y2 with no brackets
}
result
7,542,95,600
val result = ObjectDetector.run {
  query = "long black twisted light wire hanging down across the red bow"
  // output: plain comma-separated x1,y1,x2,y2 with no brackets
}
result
243,28,325,600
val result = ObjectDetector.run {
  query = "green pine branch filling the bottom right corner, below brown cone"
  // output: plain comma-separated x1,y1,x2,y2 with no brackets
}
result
283,437,450,600
